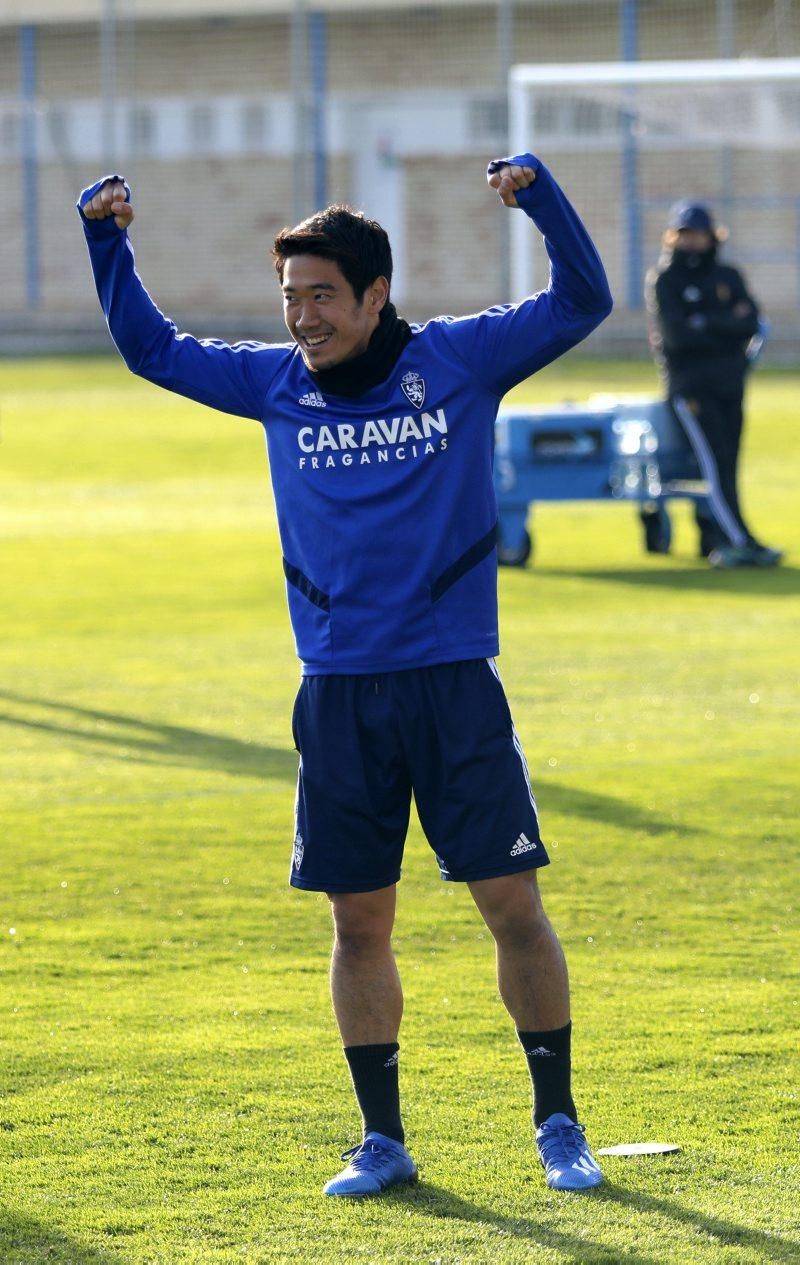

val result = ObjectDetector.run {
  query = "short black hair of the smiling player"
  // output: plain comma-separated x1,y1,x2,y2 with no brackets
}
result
272,205,392,302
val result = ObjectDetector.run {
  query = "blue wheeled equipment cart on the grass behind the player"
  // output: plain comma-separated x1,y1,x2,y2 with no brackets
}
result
495,397,708,567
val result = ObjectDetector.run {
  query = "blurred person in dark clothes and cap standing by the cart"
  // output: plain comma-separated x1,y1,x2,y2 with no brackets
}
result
642,200,782,568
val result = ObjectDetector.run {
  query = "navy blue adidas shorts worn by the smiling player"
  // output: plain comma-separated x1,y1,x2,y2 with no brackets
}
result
290,659,548,892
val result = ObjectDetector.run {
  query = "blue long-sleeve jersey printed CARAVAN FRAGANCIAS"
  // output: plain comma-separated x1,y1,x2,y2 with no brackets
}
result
78,154,611,676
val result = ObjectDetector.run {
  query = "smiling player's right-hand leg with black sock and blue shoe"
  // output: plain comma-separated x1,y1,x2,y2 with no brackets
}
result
468,870,603,1190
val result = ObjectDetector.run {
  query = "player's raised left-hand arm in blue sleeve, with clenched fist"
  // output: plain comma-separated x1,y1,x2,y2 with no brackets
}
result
77,176,279,420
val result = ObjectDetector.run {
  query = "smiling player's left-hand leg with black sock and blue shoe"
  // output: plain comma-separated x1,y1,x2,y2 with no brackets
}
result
325,886,416,1197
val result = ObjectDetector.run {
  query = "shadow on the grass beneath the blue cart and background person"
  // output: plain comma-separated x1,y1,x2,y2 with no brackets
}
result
529,567,800,597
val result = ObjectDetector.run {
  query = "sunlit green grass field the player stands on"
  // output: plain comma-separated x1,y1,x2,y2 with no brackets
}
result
0,359,800,1265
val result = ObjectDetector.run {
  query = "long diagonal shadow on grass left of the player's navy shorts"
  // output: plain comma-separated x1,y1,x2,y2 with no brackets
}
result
0,689,297,783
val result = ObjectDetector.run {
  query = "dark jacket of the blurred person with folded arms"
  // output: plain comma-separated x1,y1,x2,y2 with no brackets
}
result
644,239,758,395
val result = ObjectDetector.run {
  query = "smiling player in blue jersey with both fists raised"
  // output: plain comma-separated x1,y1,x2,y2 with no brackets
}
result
78,154,611,1195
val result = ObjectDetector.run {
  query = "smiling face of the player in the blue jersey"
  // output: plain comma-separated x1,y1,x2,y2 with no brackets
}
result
282,254,389,373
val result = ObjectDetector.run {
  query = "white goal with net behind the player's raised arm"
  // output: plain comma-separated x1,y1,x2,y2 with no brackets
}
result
509,57,800,324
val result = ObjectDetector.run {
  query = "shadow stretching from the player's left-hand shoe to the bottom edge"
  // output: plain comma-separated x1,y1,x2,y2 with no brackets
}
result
392,1182,663,1265
